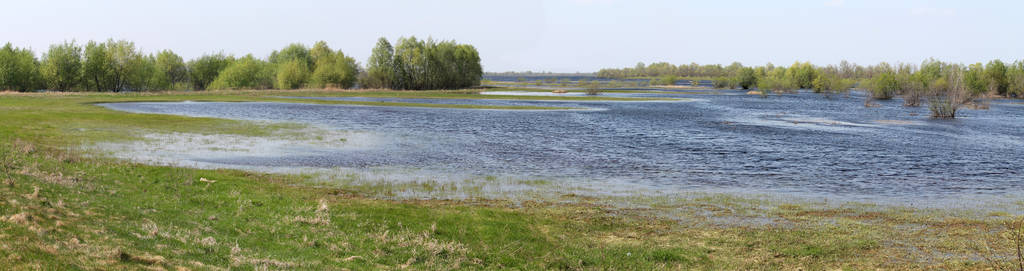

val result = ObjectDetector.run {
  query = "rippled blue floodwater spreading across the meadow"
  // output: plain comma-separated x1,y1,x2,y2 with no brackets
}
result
102,91,1024,202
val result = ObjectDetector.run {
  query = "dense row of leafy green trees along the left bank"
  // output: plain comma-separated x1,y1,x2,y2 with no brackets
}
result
0,37,482,91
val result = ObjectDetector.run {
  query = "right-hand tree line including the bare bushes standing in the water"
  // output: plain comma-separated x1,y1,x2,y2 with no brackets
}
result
598,59,1024,118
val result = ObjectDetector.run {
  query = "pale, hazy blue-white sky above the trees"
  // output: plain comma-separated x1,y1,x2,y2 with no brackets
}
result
0,0,1024,73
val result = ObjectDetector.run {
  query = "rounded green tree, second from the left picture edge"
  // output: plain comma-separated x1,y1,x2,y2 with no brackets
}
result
41,41,82,90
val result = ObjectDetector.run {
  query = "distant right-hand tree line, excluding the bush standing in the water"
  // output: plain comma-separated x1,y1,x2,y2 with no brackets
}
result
597,59,1024,99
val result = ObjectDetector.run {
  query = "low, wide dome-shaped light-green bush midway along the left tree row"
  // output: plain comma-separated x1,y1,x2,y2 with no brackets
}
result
208,54,274,89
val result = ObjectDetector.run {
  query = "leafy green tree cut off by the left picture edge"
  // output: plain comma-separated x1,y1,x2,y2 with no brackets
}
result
0,43,43,91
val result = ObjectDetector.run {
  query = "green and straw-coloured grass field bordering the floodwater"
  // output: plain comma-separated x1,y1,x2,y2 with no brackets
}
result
0,88,1024,270
